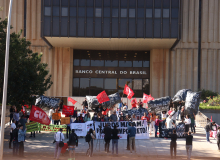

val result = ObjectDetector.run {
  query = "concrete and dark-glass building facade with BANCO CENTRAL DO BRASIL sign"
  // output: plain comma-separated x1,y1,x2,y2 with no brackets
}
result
0,0,220,98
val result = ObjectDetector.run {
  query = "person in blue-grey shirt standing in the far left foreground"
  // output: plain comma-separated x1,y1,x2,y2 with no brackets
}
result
18,125,27,157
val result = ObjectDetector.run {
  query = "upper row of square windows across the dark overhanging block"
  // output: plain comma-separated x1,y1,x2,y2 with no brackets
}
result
44,7,178,18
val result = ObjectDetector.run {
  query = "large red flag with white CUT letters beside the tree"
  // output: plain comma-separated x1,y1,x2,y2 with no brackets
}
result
29,106,50,125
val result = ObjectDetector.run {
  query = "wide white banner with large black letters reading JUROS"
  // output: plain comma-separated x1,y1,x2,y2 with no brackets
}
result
95,120,149,139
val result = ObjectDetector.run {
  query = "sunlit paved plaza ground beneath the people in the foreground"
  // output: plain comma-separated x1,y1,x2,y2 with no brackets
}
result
4,124,220,160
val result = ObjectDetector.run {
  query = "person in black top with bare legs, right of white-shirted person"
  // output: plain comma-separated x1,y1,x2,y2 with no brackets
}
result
68,129,78,160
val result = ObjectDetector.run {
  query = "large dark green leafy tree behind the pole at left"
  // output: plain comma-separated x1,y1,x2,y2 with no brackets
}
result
0,19,53,107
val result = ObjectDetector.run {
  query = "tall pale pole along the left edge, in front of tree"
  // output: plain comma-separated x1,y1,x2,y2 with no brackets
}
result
0,0,13,160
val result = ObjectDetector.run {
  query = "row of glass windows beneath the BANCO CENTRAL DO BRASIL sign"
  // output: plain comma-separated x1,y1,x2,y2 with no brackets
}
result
73,78,149,97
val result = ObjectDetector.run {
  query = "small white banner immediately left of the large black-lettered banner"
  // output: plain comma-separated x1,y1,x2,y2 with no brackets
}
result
70,121,94,136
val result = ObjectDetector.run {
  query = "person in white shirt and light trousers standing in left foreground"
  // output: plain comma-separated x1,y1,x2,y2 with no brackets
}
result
54,128,64,159
